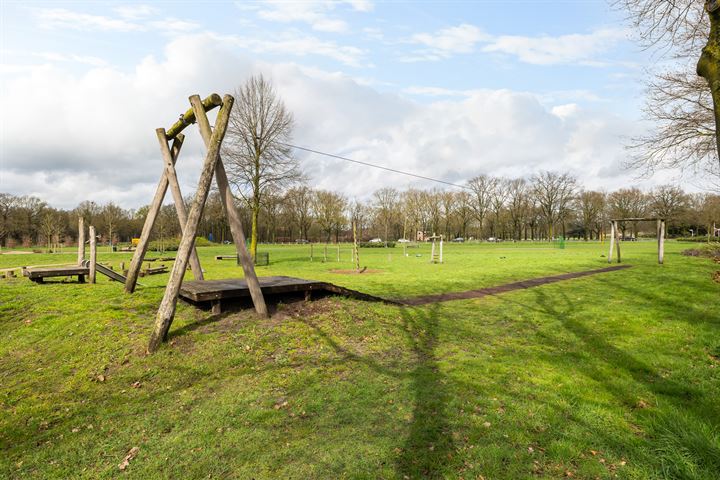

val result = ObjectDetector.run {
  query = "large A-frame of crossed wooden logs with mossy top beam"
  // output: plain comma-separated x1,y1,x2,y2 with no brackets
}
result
125,94,268,353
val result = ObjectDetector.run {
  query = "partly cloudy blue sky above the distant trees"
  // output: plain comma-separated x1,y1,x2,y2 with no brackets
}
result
0,0,669,207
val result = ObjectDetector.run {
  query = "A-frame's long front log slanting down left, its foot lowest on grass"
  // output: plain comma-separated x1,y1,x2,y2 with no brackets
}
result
148,95,234,353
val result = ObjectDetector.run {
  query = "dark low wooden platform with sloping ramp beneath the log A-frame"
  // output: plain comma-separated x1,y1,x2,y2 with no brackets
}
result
180,276,395,313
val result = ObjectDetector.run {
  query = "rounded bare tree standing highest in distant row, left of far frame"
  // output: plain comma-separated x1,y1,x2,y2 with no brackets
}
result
532,171,577,240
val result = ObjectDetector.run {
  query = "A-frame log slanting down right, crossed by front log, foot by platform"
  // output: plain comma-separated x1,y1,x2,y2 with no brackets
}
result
190,95,268,317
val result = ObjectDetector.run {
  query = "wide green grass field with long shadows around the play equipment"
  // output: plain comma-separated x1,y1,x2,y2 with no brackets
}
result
0,242,720,480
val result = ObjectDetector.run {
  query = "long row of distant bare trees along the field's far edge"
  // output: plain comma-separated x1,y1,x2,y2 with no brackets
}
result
0,172,720,249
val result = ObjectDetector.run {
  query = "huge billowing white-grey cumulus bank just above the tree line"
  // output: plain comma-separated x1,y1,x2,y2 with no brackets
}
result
0,35,648,207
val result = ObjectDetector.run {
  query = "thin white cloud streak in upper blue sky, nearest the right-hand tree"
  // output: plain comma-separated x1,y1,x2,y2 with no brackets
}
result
482,28,627,66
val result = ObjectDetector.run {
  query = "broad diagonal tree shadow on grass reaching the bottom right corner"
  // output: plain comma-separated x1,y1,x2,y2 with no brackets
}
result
502,287,720,479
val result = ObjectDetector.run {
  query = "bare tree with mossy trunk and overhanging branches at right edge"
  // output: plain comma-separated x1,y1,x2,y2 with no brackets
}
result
613,0,720,188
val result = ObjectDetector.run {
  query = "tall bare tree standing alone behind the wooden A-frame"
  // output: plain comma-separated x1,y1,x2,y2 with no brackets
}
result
223,75,302,257
